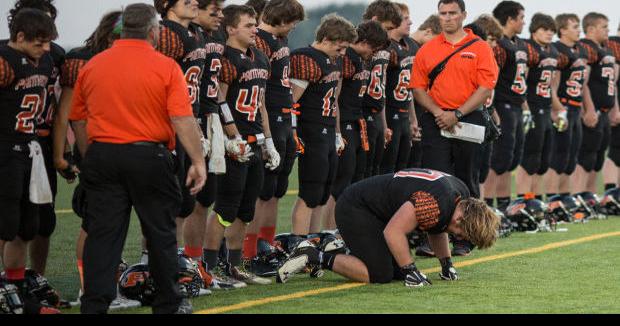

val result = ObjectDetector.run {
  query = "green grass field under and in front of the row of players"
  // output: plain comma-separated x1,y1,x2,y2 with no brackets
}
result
12,167,620,314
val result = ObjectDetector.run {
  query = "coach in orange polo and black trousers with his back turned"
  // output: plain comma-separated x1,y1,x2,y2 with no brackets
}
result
69,4,206,313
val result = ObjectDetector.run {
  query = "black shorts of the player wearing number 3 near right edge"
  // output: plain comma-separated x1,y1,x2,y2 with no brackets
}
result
578,111,611,172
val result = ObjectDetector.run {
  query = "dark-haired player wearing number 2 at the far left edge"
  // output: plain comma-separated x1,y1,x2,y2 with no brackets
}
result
0,8,58,314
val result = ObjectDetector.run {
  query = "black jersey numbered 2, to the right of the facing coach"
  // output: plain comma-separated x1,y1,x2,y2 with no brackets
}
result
526,39,558,109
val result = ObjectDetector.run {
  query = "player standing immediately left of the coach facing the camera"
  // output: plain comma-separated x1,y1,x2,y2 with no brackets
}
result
379,3,421,174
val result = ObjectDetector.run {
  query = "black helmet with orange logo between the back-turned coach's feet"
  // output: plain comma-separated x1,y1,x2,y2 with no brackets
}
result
118,264,157,306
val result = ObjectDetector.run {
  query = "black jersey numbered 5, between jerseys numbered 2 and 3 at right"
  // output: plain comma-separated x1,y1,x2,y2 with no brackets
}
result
554,41,588,106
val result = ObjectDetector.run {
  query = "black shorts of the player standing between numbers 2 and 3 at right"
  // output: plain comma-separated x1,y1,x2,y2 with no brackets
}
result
550,106,582,175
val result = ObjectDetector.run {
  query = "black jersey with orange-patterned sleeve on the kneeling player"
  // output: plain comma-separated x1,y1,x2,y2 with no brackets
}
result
343,169,470,234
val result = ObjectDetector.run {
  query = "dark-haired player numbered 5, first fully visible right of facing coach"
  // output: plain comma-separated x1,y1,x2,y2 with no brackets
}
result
484,1,527,210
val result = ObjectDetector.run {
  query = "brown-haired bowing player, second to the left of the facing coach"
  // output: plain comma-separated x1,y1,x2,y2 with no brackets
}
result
353,0,402,178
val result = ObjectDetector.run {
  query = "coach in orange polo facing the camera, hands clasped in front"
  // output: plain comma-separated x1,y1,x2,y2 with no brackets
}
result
410,0,498,197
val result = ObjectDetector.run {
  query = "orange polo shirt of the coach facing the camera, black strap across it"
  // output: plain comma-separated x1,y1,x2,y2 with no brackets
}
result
409,28,499,109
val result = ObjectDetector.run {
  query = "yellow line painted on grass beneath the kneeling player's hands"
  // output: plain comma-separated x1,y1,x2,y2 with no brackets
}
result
195,231,620,314
